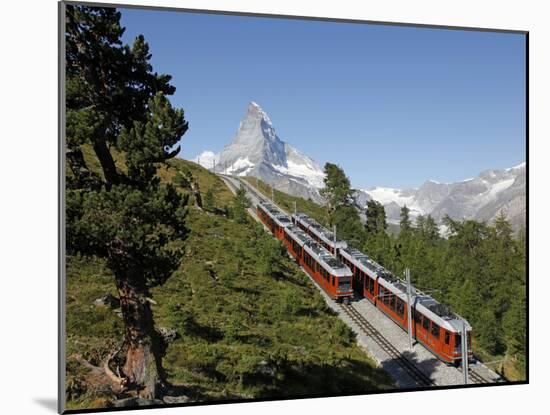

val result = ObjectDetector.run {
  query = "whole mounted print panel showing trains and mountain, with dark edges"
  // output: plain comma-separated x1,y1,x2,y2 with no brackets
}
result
59,2,528,412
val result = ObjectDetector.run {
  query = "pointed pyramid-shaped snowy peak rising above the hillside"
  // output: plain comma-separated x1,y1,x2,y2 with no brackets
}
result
217,102,324,201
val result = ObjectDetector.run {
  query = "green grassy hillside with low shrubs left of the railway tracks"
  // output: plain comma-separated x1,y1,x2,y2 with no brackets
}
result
67,150,393,409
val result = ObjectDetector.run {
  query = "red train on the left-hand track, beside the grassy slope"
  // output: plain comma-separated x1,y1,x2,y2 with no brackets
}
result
256,202,353,302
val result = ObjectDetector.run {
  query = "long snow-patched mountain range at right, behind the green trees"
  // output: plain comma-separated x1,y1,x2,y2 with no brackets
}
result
355,163,526,228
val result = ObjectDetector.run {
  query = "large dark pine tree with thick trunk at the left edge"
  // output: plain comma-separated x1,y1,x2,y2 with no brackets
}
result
66,5,188,398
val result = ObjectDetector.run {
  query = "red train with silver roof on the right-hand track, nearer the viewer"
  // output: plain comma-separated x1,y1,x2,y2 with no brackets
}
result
292,213,473,364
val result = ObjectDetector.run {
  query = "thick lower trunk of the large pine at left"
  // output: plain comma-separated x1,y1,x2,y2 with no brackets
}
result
117,271,163,399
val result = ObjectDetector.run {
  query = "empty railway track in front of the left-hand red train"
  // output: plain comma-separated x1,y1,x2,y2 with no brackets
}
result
340,304,435,387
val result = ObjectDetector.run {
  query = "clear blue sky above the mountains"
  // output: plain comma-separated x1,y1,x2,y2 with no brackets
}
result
122,9,526,188
